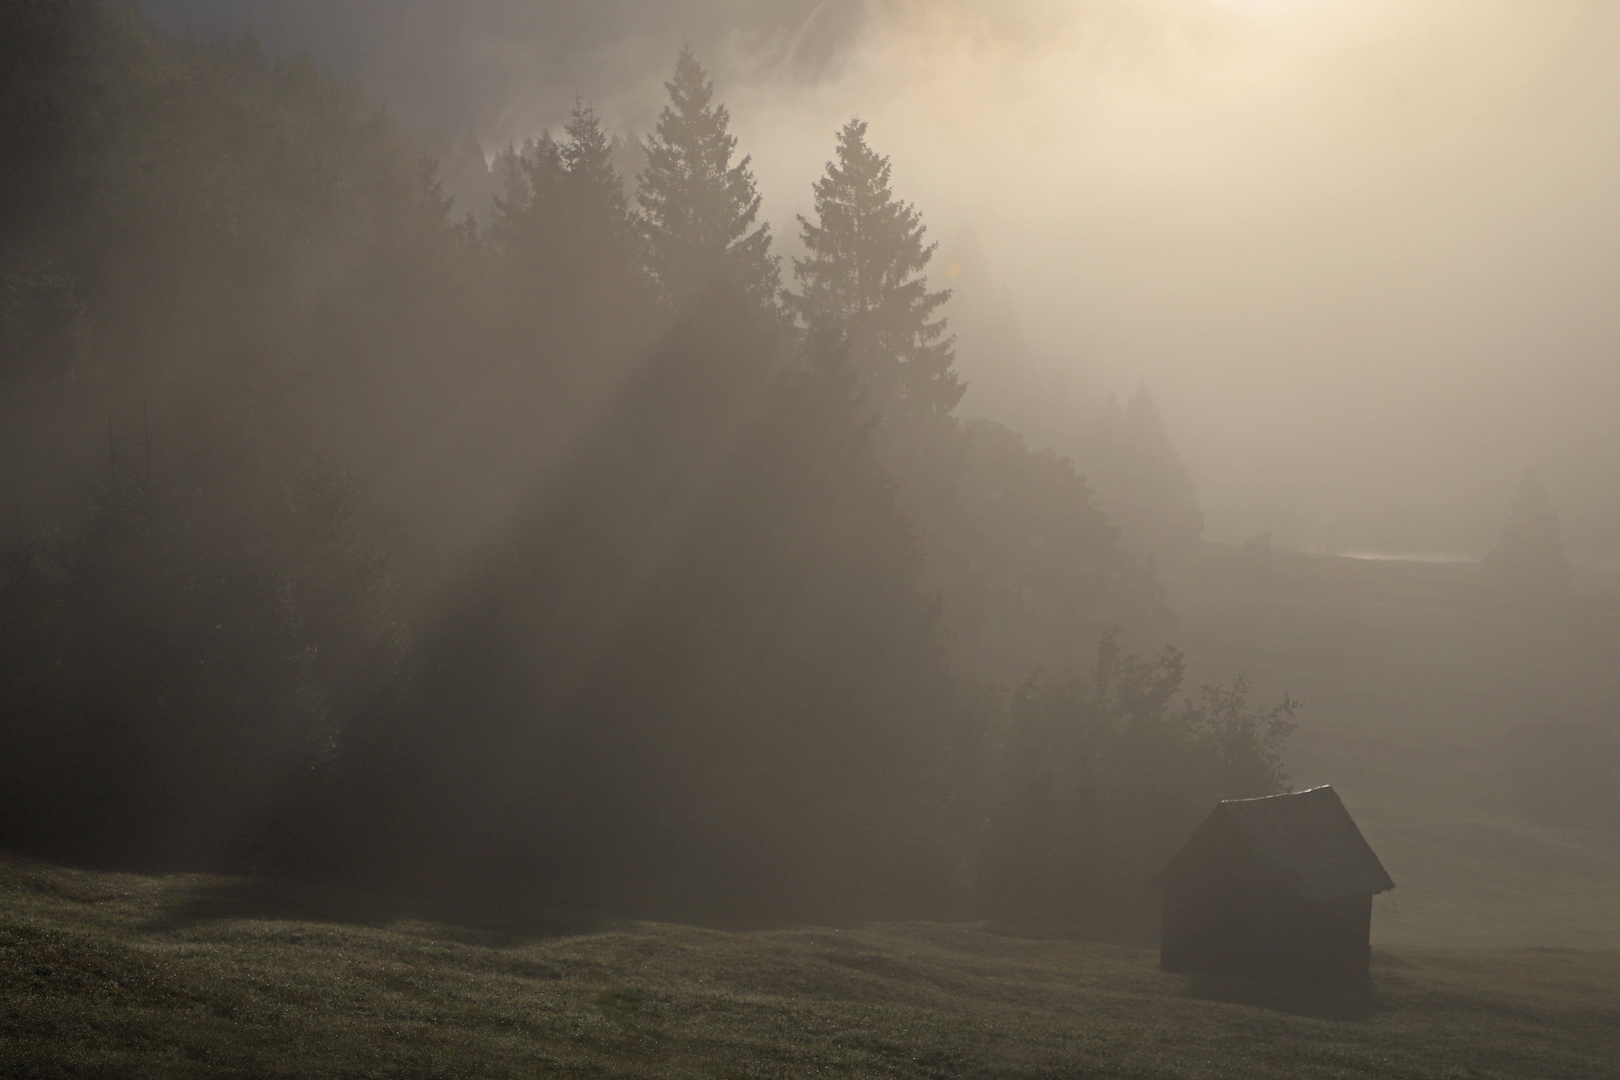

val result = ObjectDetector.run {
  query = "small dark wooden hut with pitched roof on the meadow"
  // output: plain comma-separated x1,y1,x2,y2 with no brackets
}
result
1153,787,1395,981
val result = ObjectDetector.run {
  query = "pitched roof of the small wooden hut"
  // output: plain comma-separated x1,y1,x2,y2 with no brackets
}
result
1153,785,1395,902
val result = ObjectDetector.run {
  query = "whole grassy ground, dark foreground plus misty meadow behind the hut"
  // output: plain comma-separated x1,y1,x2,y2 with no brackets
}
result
0,546,1620,1077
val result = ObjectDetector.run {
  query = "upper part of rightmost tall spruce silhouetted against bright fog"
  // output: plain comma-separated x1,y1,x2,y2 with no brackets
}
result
787,118,966,427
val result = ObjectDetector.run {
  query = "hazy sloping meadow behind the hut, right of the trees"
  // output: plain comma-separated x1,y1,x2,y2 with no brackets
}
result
1170,546,1620,949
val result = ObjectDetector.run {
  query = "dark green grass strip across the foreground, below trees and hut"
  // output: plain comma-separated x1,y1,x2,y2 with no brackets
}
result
0,860,1620,1080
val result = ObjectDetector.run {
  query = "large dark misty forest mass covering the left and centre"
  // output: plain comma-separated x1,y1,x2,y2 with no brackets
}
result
0,0,1290,921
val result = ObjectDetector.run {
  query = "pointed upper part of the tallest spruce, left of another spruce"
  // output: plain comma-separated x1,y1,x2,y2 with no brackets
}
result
637,49,781,309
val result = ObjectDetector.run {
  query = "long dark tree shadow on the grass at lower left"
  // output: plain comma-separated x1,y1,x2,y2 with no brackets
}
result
149,878,616,946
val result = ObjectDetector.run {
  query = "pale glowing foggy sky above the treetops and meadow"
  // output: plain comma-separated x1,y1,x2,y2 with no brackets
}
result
147,0,1620,557
